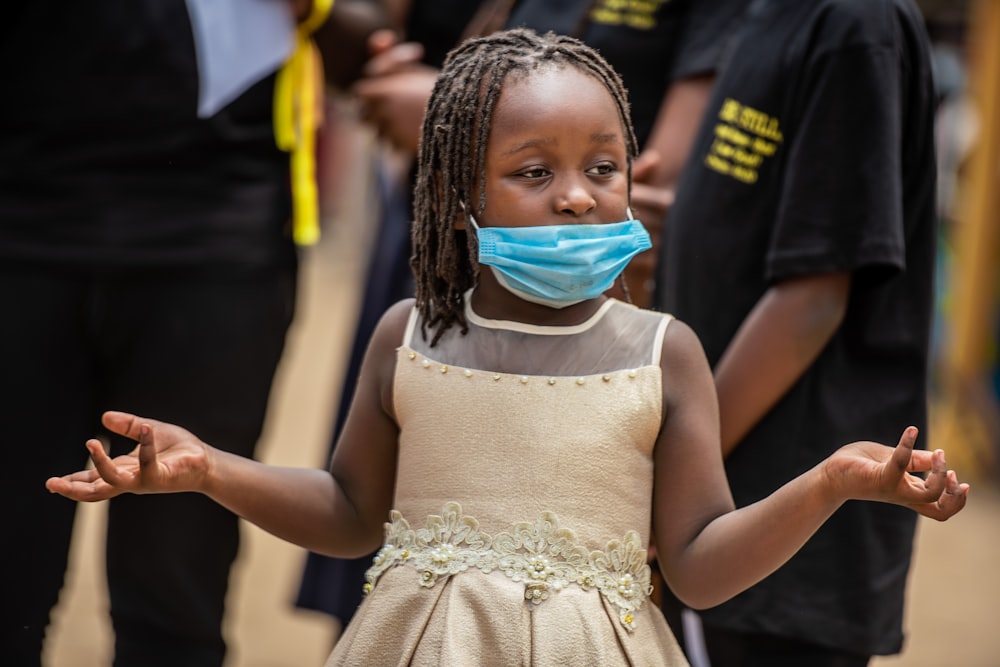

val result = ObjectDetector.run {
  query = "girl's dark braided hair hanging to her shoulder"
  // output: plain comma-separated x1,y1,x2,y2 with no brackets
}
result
410,29,638,345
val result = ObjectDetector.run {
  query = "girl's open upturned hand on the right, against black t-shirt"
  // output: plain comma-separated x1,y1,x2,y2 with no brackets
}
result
826,426,969,521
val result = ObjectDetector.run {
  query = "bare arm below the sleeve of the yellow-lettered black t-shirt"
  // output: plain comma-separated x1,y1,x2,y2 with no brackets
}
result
714,272,851,456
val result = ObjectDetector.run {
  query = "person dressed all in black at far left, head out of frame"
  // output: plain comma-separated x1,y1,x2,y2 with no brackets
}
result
0,0,332,667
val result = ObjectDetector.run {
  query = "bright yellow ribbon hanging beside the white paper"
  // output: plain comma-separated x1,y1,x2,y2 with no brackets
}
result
274,0,333,245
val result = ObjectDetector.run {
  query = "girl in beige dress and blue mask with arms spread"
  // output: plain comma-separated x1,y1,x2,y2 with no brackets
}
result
48,30,968,665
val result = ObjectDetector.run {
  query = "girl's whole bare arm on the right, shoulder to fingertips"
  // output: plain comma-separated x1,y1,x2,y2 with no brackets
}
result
653,322,968,608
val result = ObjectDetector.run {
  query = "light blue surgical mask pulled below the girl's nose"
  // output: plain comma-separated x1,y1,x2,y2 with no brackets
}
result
469,211,652,308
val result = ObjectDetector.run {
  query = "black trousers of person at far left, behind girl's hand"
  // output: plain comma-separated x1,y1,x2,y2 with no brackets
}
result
6,267,296,667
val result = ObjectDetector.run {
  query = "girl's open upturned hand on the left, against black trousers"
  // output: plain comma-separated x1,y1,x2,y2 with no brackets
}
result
45,412,211,502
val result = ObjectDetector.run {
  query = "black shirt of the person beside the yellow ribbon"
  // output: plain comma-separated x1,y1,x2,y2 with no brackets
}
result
0,0,295,269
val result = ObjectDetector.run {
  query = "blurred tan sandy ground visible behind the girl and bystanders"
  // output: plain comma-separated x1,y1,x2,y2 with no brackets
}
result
46,103,1000,667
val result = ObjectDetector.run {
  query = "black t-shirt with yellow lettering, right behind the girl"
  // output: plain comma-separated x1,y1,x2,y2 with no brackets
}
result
657,0,936,654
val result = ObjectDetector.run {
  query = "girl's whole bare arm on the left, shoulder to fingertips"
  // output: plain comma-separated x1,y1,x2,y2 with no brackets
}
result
46,301,412,557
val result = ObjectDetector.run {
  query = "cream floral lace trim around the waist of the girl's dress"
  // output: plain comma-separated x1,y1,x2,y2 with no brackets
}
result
365,503,653,632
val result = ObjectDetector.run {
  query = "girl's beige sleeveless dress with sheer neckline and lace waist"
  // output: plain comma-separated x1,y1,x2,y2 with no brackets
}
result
327,295,687,667
